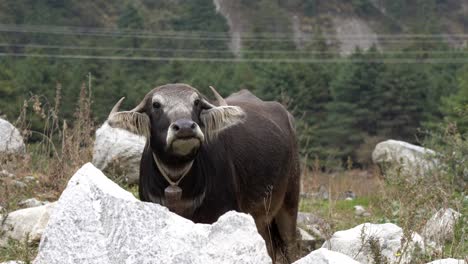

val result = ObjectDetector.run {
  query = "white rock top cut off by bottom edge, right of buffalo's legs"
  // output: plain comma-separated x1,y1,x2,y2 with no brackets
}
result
293,248,359,264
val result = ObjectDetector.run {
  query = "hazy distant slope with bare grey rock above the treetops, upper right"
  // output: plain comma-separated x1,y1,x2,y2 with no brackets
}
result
214,0,468,54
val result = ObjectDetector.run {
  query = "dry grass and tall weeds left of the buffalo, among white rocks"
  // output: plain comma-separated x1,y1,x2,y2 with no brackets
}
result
0,77,95,263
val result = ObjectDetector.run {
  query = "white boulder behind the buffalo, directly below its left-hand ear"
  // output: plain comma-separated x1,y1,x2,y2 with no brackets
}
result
92,122,146,183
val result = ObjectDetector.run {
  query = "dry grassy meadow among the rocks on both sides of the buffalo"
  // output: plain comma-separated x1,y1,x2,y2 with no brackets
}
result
0,83,468,263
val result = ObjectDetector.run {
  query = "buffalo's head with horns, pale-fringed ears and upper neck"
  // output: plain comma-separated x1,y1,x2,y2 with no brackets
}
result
108,84,245,185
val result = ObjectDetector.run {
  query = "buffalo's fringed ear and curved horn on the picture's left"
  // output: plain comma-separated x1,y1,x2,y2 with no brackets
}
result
107,97,150,138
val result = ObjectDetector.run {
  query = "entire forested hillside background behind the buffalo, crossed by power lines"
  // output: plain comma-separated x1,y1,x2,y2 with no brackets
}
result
0,0,468,163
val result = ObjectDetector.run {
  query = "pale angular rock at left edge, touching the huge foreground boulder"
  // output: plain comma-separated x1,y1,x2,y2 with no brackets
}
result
0,203,55,246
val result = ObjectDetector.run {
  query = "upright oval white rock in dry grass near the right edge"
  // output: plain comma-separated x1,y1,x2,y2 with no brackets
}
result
421,208,461,245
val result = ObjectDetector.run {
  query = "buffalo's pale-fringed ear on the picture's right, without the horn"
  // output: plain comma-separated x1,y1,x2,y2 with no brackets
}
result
200,101,246,141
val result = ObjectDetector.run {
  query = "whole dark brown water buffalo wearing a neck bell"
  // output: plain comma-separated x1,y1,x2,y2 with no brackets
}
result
108,84,300,262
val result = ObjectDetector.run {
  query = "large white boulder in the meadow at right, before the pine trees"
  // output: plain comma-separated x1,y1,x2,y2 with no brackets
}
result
372,139,437,176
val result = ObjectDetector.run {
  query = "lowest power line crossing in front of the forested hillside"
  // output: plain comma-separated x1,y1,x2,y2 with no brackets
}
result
0,53,468,64
